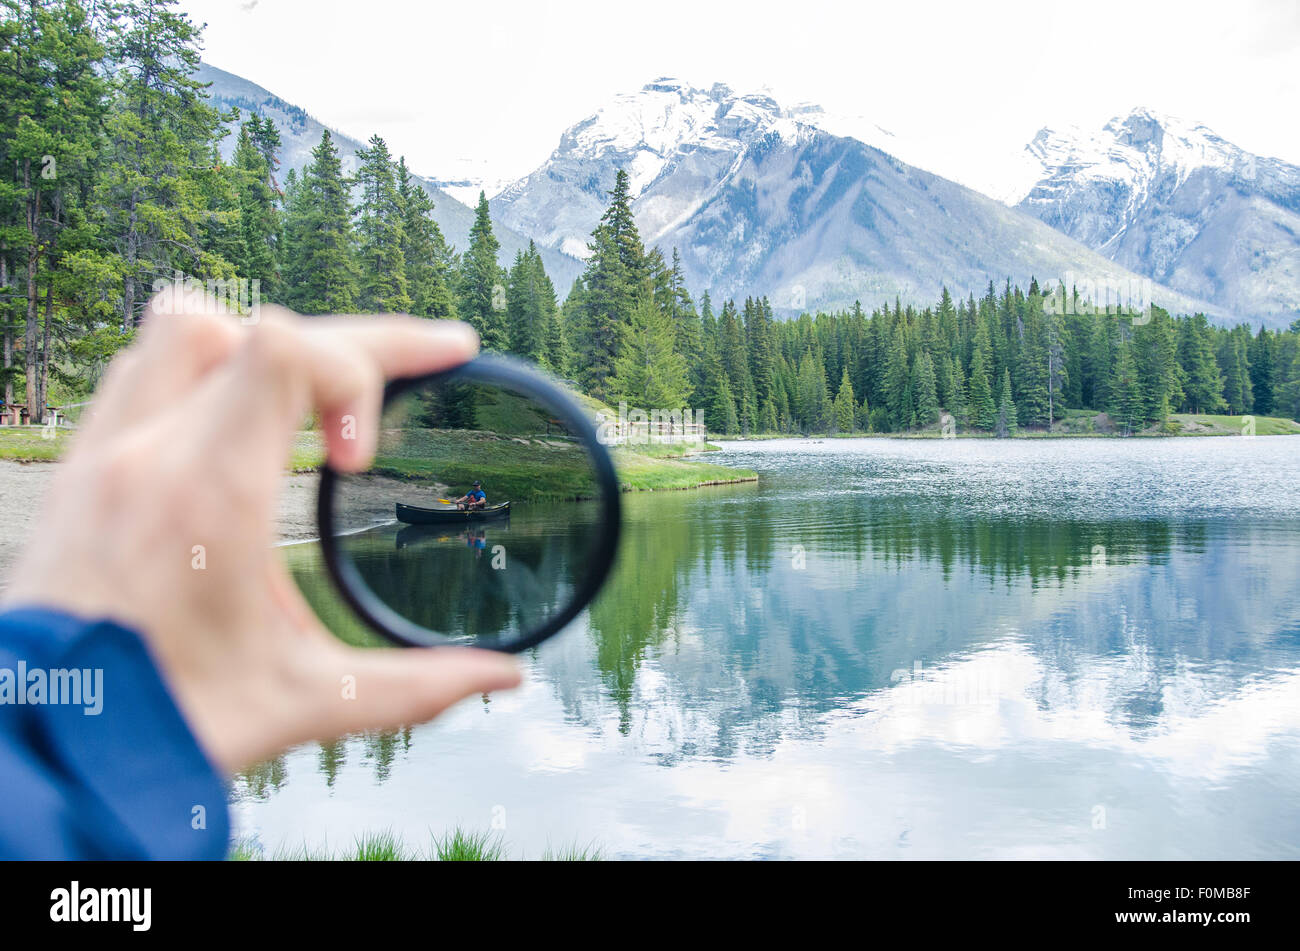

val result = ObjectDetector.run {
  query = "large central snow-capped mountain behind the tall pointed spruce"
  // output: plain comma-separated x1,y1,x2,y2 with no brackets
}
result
494,79,1203,312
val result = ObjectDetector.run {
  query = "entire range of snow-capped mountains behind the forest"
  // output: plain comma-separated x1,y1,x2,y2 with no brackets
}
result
203,65,1284,326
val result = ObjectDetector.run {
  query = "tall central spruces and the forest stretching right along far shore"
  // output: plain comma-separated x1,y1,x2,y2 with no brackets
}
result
562,171,1300,435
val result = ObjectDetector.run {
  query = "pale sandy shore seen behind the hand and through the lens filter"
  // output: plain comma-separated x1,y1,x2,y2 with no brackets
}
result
0,460,432,589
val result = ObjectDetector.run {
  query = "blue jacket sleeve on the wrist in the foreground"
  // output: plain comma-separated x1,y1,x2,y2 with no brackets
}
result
0,608,230,859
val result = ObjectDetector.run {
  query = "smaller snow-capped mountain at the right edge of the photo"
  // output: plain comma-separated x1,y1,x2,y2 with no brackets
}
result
1005,109,1300,325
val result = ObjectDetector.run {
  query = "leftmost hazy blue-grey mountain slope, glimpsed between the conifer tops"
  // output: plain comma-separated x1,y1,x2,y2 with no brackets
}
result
199,62,582,295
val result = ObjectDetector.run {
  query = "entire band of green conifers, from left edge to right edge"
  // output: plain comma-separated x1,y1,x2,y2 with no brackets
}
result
0,0,1300,434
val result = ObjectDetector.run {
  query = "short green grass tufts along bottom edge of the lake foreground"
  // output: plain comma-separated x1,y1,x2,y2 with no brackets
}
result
226,826,605,861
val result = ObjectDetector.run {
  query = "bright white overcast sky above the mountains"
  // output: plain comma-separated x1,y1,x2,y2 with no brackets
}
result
181,0,1300,194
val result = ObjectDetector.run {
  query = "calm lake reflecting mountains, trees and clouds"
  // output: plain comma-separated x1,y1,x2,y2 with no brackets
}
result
231,437,1300,859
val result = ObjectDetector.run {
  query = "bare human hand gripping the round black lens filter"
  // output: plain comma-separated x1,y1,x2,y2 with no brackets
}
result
7,294,519,772
